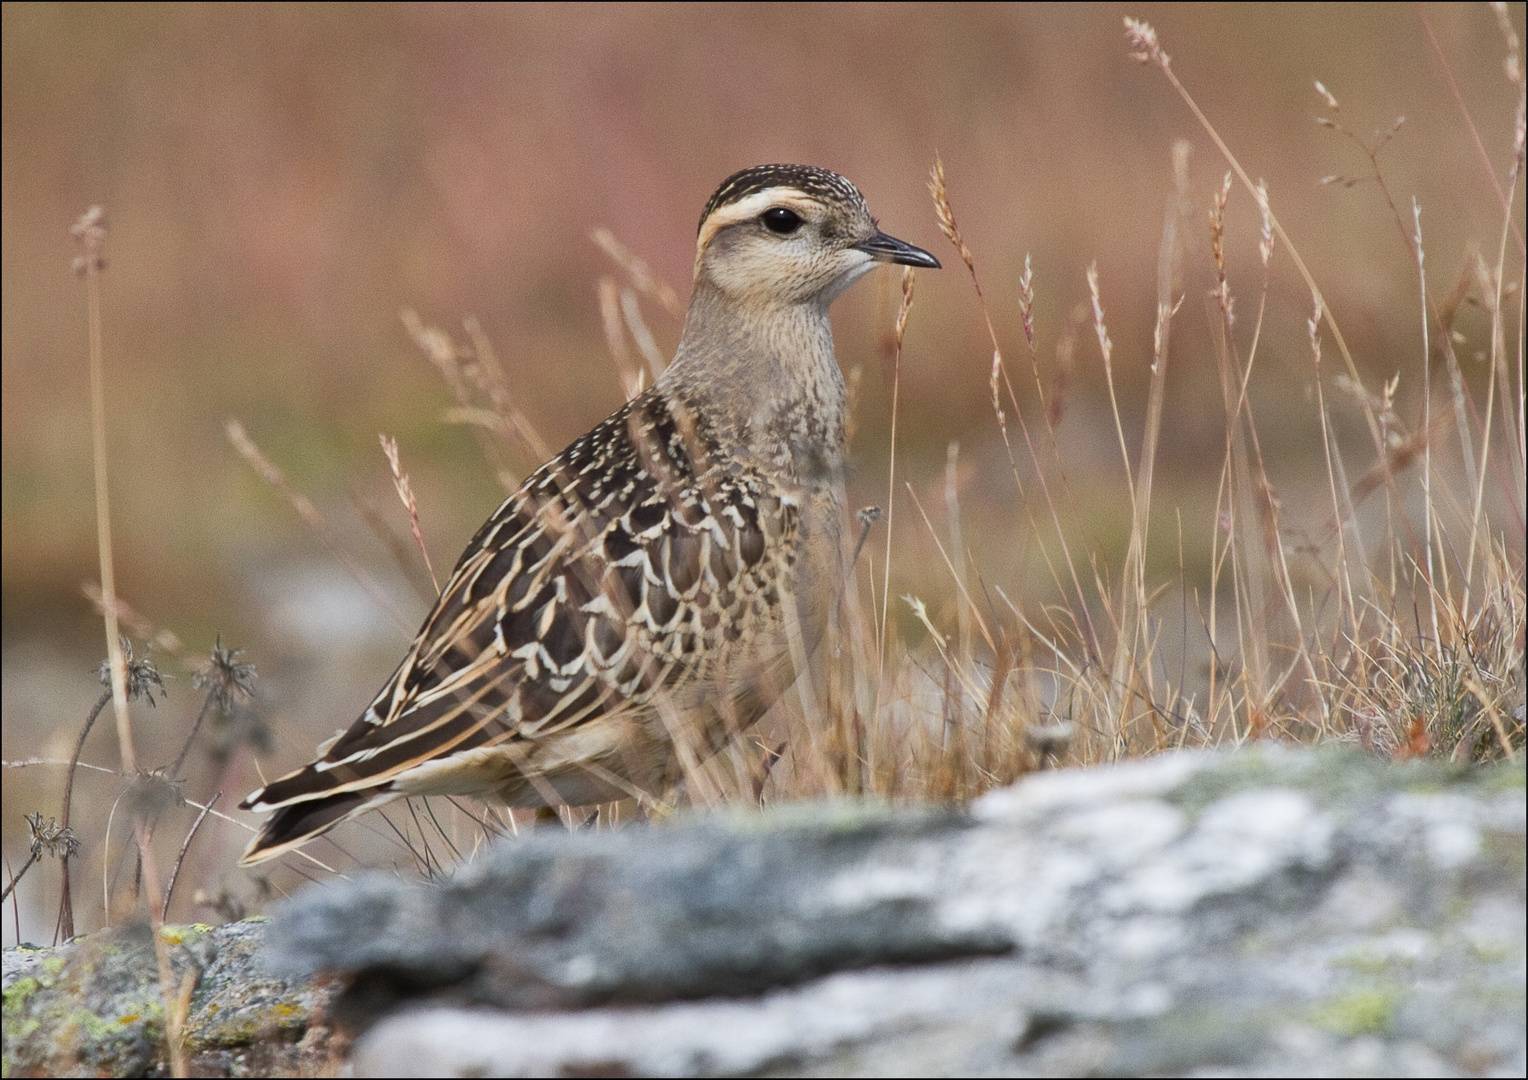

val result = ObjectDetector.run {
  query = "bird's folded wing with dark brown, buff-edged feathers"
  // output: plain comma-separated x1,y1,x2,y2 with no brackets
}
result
241,388,796,818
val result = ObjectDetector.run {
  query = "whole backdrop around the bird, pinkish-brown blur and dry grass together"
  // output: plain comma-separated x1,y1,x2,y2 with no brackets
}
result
0,5,1525,943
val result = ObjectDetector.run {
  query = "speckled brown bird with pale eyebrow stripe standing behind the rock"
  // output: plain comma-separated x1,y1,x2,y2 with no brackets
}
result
240,165,940,866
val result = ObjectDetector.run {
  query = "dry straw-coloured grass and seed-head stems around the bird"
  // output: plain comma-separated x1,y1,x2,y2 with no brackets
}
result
6,23,1528,1057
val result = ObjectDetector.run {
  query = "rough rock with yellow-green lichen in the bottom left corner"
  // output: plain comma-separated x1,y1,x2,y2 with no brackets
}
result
3,920,329,1077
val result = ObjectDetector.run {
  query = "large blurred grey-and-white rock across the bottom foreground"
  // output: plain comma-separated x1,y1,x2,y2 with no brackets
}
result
6,747,1528,1075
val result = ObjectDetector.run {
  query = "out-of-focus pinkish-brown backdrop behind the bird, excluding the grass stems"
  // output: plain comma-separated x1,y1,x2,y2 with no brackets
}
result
0,3,1523,941
